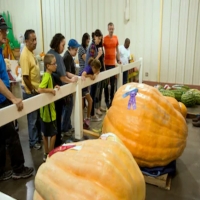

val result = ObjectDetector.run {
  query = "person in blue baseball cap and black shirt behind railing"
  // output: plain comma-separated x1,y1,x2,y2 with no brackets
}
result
61,39,80,136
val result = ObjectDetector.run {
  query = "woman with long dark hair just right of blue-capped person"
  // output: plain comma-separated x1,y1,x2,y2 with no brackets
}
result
78,33,90,73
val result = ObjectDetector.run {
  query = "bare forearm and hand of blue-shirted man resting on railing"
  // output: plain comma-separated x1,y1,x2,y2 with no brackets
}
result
0,79,23,111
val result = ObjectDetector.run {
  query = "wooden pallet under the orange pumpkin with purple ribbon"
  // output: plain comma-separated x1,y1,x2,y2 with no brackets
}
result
143,174,172,190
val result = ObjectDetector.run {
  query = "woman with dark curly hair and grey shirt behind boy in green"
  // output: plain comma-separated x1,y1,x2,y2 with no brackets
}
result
47,33,78,147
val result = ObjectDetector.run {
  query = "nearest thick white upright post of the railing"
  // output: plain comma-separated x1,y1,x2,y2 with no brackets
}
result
74,78,83,140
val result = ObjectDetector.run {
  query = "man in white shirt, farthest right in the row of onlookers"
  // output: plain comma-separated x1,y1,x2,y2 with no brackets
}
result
119,38,130,85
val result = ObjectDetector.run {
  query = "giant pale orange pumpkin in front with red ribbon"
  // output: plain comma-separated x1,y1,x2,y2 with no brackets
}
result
33,134,145,200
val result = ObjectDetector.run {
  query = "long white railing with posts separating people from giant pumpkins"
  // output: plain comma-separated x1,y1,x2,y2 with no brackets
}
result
0,58,143,139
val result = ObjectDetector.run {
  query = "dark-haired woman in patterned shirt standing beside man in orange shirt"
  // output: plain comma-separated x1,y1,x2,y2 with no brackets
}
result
85,29,103,122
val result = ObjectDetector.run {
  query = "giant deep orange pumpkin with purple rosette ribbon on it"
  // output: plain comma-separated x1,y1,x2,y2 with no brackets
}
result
102,83,187,167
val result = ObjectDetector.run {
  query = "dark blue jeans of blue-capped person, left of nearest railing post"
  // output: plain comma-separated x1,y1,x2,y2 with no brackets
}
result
61,95,73,132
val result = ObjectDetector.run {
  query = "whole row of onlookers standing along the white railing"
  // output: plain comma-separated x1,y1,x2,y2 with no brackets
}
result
0,16,130,180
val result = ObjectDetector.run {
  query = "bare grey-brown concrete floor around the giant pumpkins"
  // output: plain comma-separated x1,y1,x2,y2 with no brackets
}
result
0,83,200,200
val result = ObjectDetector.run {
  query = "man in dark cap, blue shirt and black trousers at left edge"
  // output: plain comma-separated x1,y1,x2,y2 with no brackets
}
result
0,15,33,181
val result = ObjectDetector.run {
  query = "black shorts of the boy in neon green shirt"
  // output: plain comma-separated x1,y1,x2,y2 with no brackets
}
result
41,120,57,137
